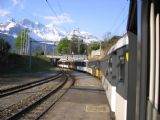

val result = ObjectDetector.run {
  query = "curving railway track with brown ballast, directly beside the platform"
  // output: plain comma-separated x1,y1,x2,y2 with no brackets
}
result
0,71,73,120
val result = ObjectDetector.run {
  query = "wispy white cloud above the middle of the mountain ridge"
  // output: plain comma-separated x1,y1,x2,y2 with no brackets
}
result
43,13,74,25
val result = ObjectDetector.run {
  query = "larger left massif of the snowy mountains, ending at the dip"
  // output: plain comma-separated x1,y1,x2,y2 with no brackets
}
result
0,19,66,45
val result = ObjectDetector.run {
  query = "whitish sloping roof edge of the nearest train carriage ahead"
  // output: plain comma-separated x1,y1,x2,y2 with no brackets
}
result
107,34,129,54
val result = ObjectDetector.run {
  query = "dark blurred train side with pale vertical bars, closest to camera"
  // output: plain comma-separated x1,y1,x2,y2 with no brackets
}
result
126,0,160,120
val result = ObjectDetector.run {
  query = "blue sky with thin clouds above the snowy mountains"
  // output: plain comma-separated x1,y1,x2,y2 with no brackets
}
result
0,0,129,39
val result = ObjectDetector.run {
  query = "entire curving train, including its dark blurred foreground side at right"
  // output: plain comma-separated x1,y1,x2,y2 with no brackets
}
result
58,0,160,120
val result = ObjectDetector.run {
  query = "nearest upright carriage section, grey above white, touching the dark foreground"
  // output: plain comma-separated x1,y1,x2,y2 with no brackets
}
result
115,47,128,120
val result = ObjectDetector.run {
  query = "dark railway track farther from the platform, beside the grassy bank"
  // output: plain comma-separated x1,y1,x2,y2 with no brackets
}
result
0,72,63,98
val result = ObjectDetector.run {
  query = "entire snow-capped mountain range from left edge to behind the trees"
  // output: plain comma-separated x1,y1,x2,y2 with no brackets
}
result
0,19,97,45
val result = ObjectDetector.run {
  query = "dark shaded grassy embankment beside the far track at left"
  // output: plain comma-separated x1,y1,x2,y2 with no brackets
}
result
0,54,54,74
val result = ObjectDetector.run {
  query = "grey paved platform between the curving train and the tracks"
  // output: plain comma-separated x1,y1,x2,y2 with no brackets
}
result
41,71,111,120
